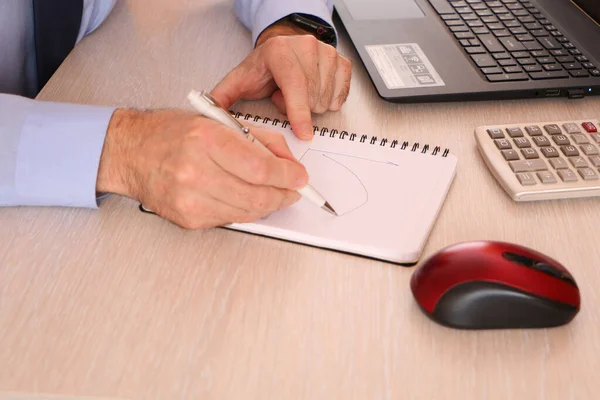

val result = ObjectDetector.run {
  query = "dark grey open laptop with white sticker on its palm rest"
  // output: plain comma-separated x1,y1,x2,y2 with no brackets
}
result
334,0,600,102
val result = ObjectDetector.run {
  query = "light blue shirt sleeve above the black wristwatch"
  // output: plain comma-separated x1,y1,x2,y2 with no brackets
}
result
235,0,333,44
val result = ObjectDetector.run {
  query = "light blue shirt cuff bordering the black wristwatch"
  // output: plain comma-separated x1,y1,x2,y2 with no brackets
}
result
252,0,337,45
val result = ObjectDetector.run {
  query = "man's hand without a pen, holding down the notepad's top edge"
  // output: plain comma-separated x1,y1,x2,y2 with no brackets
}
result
212,24,352,139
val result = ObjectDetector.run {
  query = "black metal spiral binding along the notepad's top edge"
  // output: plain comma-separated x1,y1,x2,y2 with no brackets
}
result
229,110,450,157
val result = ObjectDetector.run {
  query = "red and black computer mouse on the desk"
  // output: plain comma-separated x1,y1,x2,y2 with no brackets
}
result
410,241,581,329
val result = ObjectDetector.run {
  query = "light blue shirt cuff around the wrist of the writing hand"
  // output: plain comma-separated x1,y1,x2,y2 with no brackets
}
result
15,101,115,208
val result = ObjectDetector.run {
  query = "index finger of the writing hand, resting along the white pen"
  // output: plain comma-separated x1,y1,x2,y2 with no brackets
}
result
205,127,308,190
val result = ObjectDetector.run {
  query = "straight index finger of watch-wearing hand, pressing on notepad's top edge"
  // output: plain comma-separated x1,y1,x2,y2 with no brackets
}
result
267,36,316,138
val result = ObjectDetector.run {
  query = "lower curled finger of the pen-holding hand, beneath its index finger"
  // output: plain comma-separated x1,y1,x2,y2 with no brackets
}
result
207,165,300,215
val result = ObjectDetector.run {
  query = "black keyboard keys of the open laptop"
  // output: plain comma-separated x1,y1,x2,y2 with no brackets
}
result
428,0,600,82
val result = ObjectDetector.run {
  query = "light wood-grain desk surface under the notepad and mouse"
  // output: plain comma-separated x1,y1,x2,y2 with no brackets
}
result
0,0,600,400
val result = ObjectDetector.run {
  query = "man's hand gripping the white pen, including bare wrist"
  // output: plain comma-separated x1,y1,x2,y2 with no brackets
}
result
96,110,308,229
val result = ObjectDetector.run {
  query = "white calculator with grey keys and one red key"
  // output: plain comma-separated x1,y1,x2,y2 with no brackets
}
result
475,119,600,201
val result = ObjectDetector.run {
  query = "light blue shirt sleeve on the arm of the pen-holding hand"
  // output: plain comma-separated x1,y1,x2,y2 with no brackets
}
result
0,94,114,208
